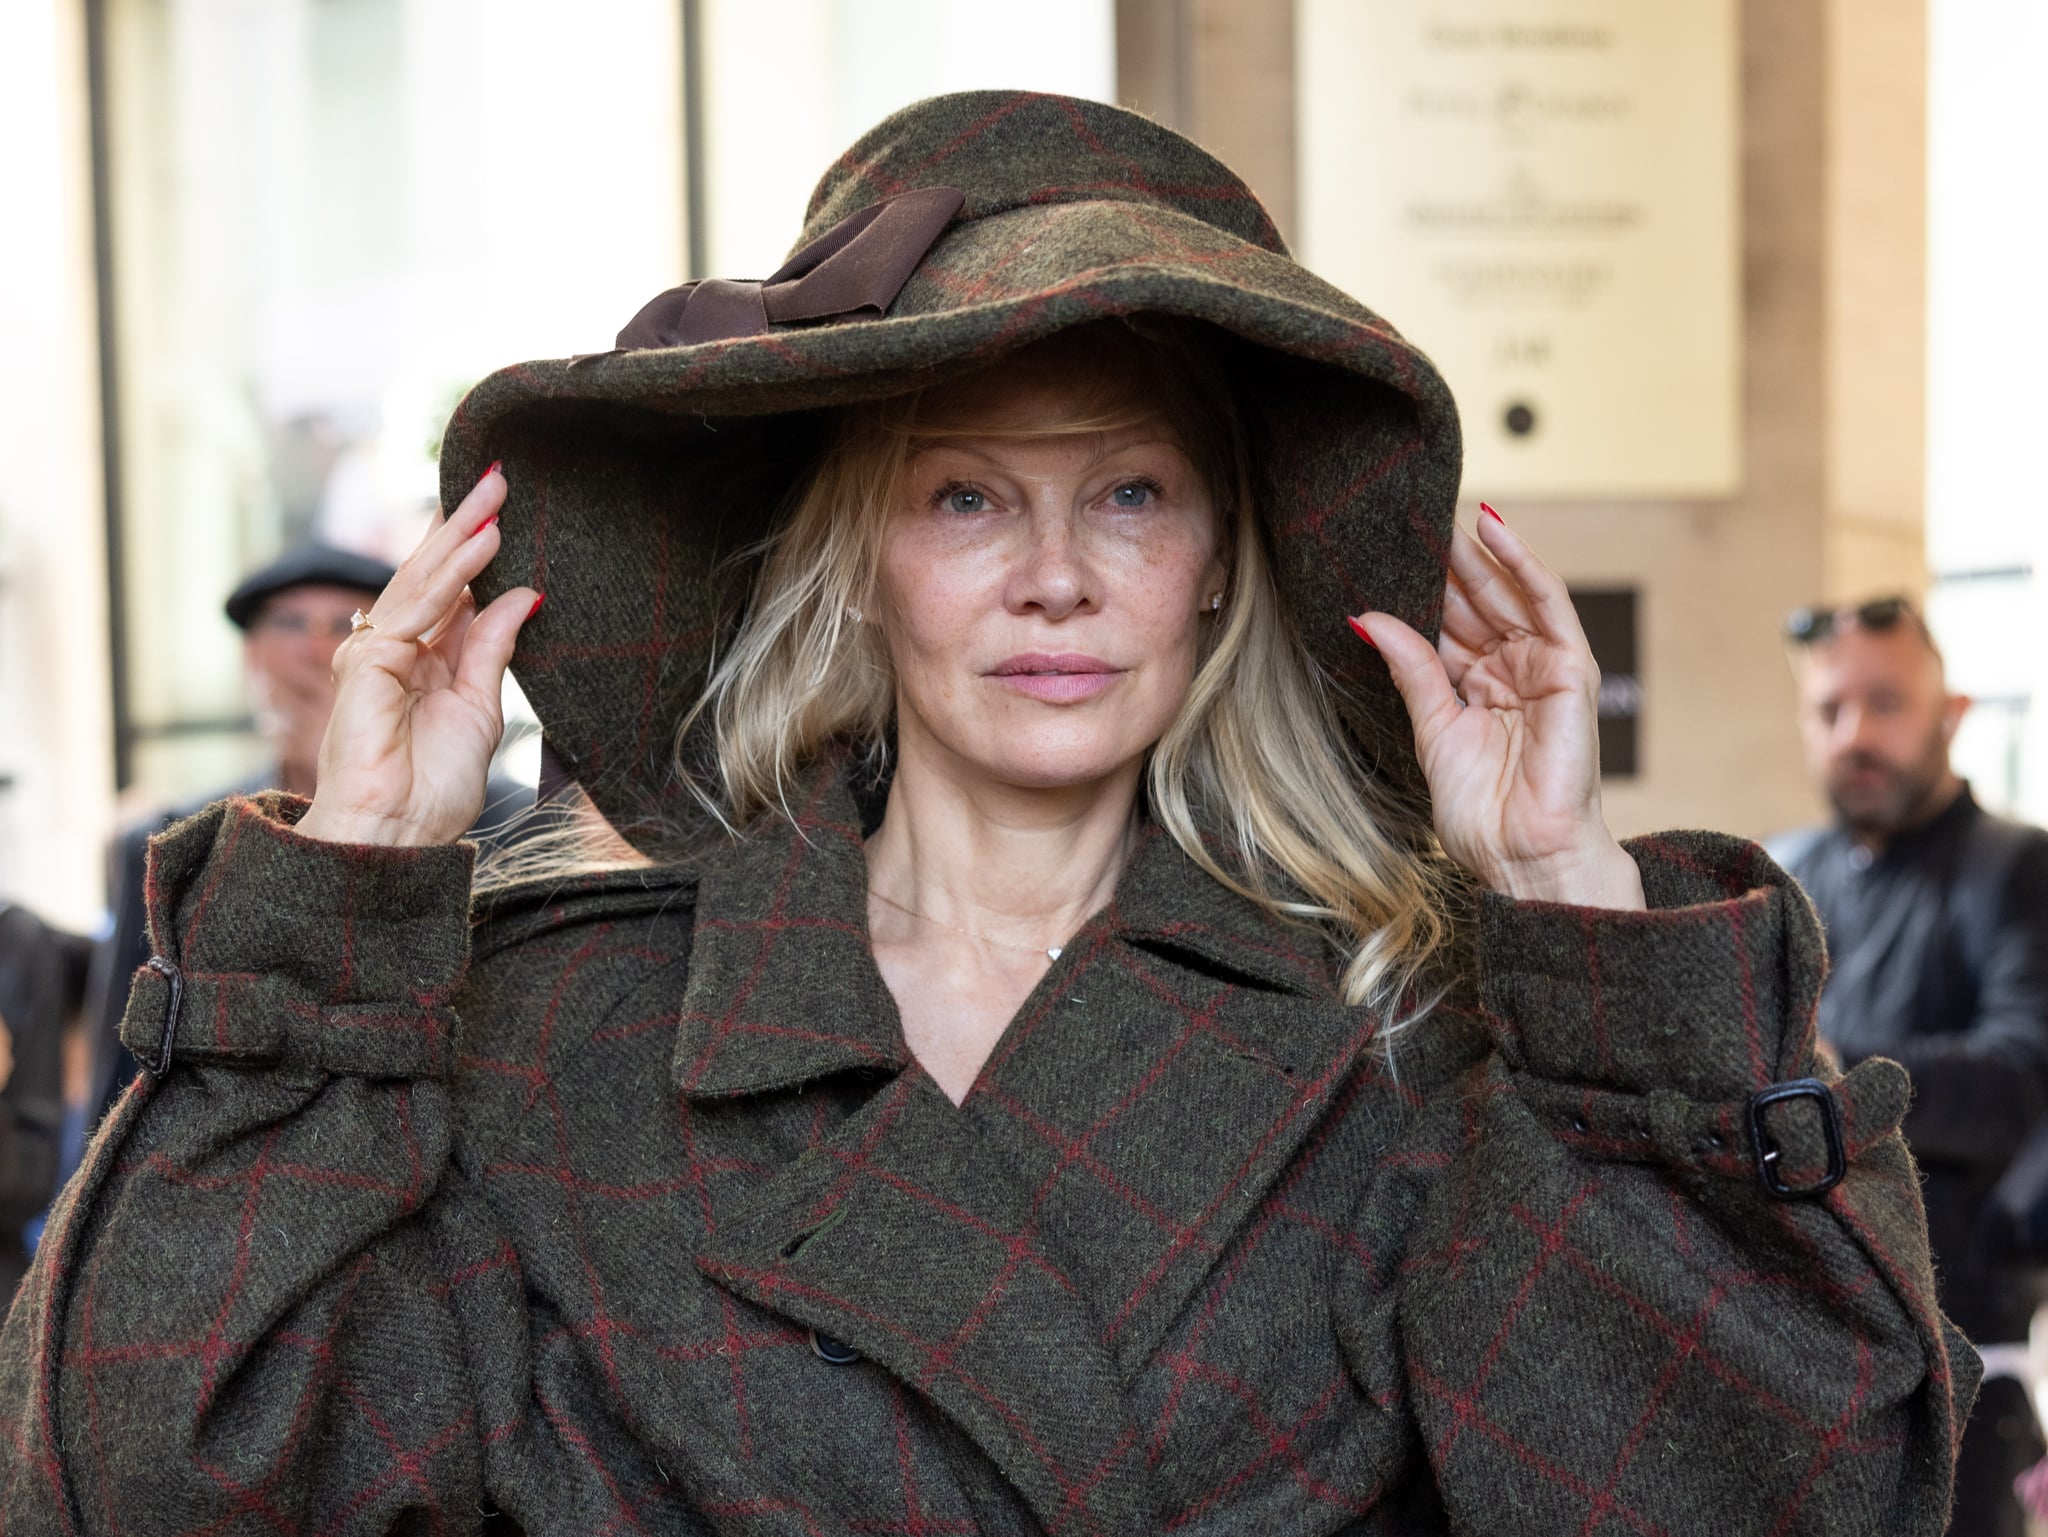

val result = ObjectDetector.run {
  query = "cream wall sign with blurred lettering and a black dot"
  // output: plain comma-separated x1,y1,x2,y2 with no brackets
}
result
1296,0,1741,498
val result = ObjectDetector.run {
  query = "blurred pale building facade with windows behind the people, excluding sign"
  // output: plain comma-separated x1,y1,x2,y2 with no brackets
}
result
0,0,2048,924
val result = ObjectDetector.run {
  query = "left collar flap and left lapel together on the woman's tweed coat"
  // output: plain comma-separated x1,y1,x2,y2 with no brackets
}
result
670,779,1151,1533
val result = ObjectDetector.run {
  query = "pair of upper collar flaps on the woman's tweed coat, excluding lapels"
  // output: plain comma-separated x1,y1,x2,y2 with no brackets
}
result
670,762,1333,1100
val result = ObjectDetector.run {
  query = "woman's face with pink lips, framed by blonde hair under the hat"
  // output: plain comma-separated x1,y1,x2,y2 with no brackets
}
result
877,350,1225,787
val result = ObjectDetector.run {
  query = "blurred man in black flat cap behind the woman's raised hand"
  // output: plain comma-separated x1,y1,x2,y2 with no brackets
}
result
86,543,532,1129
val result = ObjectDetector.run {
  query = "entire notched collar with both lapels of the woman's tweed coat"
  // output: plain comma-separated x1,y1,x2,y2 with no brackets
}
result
672,779,1372,1533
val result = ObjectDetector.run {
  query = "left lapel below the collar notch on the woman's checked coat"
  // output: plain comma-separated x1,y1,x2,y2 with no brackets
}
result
696,1068,1151,1533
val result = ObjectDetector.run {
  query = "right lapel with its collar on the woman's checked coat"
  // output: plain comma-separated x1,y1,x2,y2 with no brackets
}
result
963,832,1374,1381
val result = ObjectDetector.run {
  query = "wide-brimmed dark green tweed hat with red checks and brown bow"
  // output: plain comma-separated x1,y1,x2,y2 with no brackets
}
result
440,90,1460,840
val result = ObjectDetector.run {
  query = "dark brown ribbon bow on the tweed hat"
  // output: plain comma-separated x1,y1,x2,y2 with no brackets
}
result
618,186,967,348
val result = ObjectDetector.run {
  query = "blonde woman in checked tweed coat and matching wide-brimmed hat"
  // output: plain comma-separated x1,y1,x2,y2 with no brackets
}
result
0,92,1974,1533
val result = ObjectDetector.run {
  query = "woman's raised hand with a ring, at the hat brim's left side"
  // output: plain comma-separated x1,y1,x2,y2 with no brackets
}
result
299,465,541,844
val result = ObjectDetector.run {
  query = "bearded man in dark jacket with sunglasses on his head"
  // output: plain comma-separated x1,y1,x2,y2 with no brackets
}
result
1772,598,2048,1537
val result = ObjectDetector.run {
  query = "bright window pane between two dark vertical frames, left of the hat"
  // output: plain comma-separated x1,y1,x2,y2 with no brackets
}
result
104,0,684,799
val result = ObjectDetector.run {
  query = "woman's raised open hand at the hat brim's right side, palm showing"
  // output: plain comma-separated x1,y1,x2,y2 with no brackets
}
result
1360,508,1645,908
